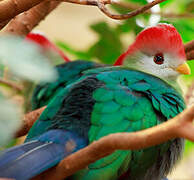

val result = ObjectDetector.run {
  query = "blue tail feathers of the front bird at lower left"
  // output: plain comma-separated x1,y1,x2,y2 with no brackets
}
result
0,130,86,180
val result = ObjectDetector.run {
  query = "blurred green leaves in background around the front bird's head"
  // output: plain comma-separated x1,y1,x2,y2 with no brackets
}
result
57,0,194,153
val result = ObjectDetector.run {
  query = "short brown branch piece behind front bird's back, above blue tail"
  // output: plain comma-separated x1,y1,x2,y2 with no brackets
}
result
15,106,46,137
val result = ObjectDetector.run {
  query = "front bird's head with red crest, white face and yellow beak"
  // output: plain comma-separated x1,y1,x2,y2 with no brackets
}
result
114,24,190,80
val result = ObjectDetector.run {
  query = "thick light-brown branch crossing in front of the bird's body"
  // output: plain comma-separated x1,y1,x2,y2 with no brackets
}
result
34,106,194,180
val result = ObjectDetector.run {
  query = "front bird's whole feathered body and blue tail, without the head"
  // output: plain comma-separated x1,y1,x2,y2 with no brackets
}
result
0,64,185,180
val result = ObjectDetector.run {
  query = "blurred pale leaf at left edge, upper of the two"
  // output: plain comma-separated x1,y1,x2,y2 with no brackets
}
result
0,36,56,81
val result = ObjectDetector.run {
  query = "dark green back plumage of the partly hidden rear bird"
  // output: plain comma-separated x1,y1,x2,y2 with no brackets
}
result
32,60,102,109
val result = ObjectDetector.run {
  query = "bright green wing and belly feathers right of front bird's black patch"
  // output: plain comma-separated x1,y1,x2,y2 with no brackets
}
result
75,68,185,180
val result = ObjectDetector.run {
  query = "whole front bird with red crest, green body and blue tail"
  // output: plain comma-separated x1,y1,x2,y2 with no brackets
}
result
0,23,190,180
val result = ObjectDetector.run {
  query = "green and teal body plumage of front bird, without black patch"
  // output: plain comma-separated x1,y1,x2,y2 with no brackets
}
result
28,64,185,180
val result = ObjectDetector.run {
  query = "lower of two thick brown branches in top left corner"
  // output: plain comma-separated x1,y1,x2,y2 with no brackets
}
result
2,1,60,36
